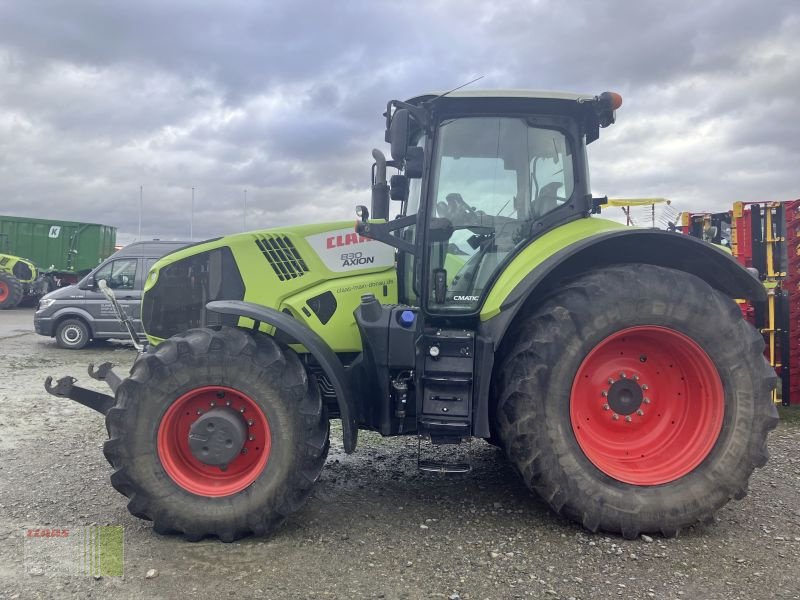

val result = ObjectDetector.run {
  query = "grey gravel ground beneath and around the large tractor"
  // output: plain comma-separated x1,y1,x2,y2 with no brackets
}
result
0,309,800,600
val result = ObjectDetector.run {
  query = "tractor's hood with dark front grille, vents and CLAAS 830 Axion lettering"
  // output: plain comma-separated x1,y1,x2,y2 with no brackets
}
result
142,221,396,342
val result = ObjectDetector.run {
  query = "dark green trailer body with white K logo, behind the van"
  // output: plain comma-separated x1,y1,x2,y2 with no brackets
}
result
0,216,117,273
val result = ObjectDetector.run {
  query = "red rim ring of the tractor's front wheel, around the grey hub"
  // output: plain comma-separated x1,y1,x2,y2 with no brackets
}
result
158,385,272,497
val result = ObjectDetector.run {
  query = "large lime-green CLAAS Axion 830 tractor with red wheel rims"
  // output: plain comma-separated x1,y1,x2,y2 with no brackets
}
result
46,91,777,541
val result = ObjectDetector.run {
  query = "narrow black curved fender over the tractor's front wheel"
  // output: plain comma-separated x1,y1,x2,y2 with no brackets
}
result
206,300,358,454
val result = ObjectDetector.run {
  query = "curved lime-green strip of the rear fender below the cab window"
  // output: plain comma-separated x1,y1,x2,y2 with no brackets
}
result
480,217,625,321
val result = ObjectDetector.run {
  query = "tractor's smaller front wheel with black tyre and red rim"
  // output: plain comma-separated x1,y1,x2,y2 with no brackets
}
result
105,327,329,542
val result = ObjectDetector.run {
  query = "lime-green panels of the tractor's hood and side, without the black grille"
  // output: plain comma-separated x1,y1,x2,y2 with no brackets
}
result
144,221,397,352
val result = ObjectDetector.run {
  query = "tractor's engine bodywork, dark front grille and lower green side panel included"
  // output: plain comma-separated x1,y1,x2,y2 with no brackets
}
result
143,221,397,352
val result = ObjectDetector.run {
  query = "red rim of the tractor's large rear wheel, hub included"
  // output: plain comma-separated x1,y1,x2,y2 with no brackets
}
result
570,326,725,485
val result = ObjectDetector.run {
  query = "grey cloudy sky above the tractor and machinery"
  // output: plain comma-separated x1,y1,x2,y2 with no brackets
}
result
0,0,800,242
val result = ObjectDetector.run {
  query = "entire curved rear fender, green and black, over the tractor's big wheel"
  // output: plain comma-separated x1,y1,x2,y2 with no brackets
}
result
481,225,767,347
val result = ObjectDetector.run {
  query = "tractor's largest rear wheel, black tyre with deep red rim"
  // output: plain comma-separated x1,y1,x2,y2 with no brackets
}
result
495,264,777,538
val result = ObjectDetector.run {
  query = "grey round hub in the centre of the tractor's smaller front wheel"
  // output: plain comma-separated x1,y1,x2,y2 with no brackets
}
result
189,408,247,469
